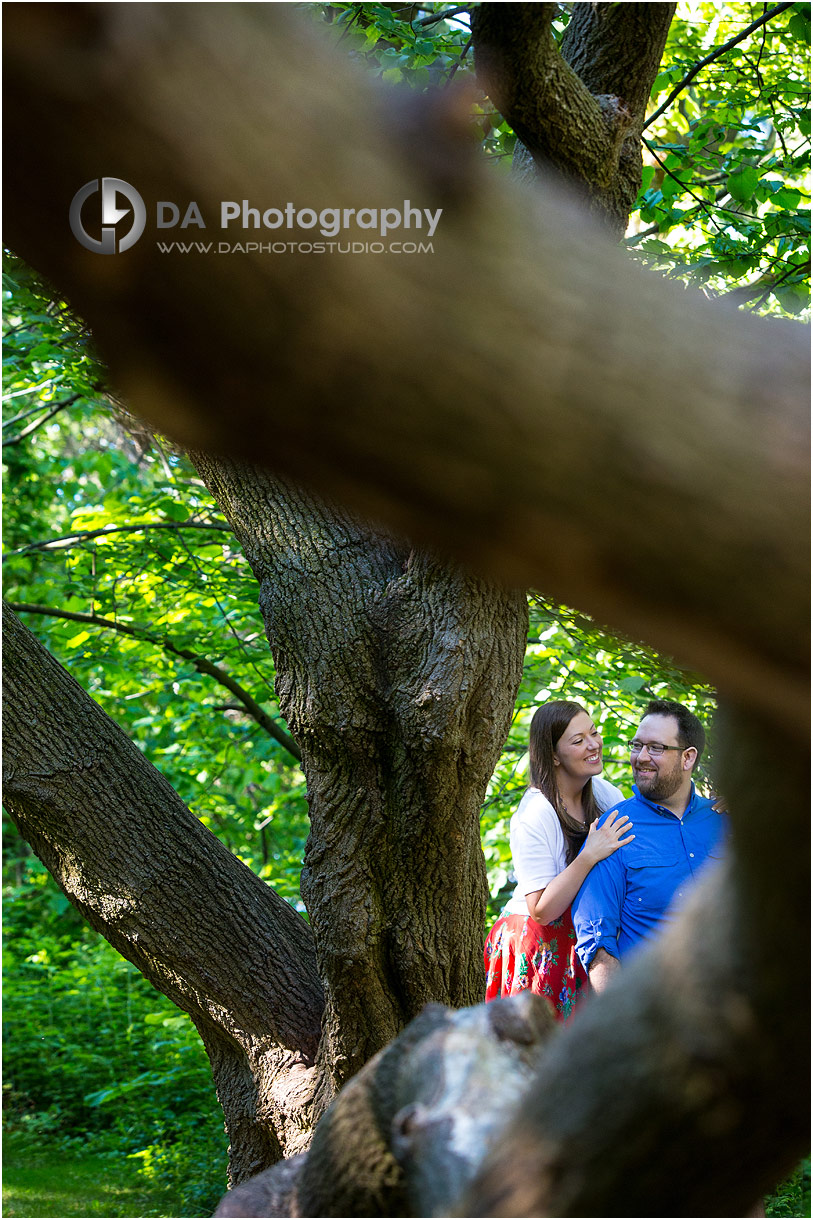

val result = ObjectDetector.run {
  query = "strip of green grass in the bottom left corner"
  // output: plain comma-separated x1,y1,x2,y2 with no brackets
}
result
2,1141,183,1218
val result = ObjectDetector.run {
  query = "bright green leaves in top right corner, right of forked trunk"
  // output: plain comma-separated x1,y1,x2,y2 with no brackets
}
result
626,4,811,316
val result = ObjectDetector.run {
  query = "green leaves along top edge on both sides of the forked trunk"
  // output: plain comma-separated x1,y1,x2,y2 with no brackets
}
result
320,2,811,316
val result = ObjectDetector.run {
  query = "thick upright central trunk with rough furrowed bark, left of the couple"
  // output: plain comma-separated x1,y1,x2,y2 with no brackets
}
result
193,454,527,1087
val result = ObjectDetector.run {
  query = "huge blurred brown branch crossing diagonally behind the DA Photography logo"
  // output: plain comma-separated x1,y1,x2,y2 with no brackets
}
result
5,5,809,722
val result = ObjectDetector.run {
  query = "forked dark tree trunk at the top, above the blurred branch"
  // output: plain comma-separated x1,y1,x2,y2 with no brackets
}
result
471,4,676,238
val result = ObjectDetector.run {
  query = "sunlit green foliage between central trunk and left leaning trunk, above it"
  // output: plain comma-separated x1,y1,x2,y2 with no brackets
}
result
4,256,306,904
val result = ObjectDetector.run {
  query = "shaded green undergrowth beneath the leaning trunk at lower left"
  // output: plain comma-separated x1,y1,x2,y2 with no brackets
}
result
2,825,226,1215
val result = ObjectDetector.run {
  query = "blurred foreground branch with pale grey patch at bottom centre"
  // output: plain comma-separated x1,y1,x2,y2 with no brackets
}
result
215,992,555,1216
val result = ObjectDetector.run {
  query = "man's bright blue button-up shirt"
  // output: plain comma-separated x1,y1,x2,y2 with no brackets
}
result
573,784,728,969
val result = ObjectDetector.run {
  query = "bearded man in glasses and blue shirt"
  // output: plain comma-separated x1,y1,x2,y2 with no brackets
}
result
573,699,726,992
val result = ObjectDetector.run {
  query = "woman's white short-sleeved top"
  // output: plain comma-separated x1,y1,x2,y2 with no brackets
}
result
503,776,625,915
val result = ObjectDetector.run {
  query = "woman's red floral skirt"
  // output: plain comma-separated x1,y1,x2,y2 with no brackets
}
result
485,908,590,1021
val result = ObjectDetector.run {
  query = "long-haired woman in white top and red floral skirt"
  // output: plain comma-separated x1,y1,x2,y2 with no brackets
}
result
485,699,635,1021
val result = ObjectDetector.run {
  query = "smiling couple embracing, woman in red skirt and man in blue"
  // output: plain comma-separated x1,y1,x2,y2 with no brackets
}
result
485,699,726,1020
